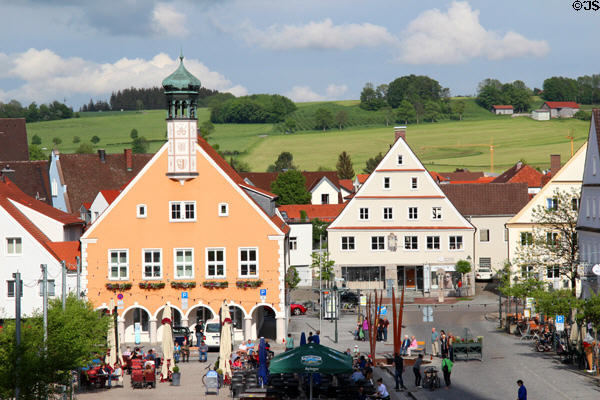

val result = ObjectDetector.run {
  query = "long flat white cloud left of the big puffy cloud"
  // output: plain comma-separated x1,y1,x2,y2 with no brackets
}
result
242,18,397,50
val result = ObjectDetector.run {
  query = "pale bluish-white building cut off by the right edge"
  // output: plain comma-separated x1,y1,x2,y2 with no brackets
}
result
577,109,600,298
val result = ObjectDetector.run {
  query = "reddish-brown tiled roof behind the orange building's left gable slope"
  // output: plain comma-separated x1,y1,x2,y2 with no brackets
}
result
59,150,153,213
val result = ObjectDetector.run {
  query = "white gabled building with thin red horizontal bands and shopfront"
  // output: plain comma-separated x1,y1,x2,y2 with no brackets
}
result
327,127,475,296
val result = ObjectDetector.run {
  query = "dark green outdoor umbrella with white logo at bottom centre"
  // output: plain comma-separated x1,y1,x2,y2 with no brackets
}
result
269,343,352,399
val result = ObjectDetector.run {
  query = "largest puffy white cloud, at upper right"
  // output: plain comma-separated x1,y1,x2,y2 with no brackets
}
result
399,1,550,64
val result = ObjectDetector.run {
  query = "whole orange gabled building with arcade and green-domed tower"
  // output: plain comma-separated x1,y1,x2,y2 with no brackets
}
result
81,57,289,343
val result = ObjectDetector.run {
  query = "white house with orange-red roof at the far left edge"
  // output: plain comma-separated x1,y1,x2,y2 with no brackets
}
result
0,177,83,318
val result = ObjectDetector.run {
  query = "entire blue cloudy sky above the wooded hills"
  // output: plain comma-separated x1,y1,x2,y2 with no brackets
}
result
0,0,600,109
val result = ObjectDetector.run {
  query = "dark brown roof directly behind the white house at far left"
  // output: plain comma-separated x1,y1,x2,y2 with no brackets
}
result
0,159,52,204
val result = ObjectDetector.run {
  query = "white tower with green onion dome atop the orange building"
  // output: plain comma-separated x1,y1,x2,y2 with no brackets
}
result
162,54,200,183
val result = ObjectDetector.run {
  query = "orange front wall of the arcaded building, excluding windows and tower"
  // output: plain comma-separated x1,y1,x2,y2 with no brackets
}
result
87,145,283,320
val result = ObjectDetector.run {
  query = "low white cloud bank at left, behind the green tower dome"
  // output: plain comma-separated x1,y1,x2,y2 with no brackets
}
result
0,49,247,103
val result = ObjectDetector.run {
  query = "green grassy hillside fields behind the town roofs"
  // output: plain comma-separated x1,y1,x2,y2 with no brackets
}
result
27,98,589,173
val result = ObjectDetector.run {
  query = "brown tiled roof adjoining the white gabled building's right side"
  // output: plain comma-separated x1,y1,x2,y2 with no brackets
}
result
440,183,529,216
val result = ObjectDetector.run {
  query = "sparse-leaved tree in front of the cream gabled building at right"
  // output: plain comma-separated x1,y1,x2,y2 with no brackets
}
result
515,189,580,295
